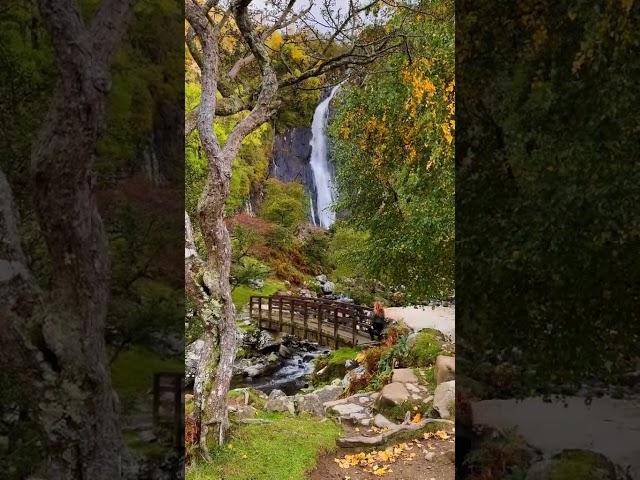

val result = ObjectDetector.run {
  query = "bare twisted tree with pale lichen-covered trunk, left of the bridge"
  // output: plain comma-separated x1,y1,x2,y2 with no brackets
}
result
185,0,405,458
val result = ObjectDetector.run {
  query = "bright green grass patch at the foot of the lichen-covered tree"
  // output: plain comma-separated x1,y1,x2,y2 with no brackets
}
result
186,413,341,480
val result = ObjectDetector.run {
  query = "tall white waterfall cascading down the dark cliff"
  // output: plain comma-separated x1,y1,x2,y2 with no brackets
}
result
309,85,340,228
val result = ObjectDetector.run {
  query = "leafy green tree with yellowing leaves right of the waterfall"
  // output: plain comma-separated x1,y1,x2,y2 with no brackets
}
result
330,0,455,300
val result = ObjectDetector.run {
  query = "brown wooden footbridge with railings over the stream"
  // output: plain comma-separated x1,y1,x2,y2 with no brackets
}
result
249,295,373,348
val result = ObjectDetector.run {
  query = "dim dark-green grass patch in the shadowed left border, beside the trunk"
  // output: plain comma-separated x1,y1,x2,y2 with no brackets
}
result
111,346,184,409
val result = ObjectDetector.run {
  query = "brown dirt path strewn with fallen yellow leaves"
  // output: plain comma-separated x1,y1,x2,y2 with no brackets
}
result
309,430,455,480
